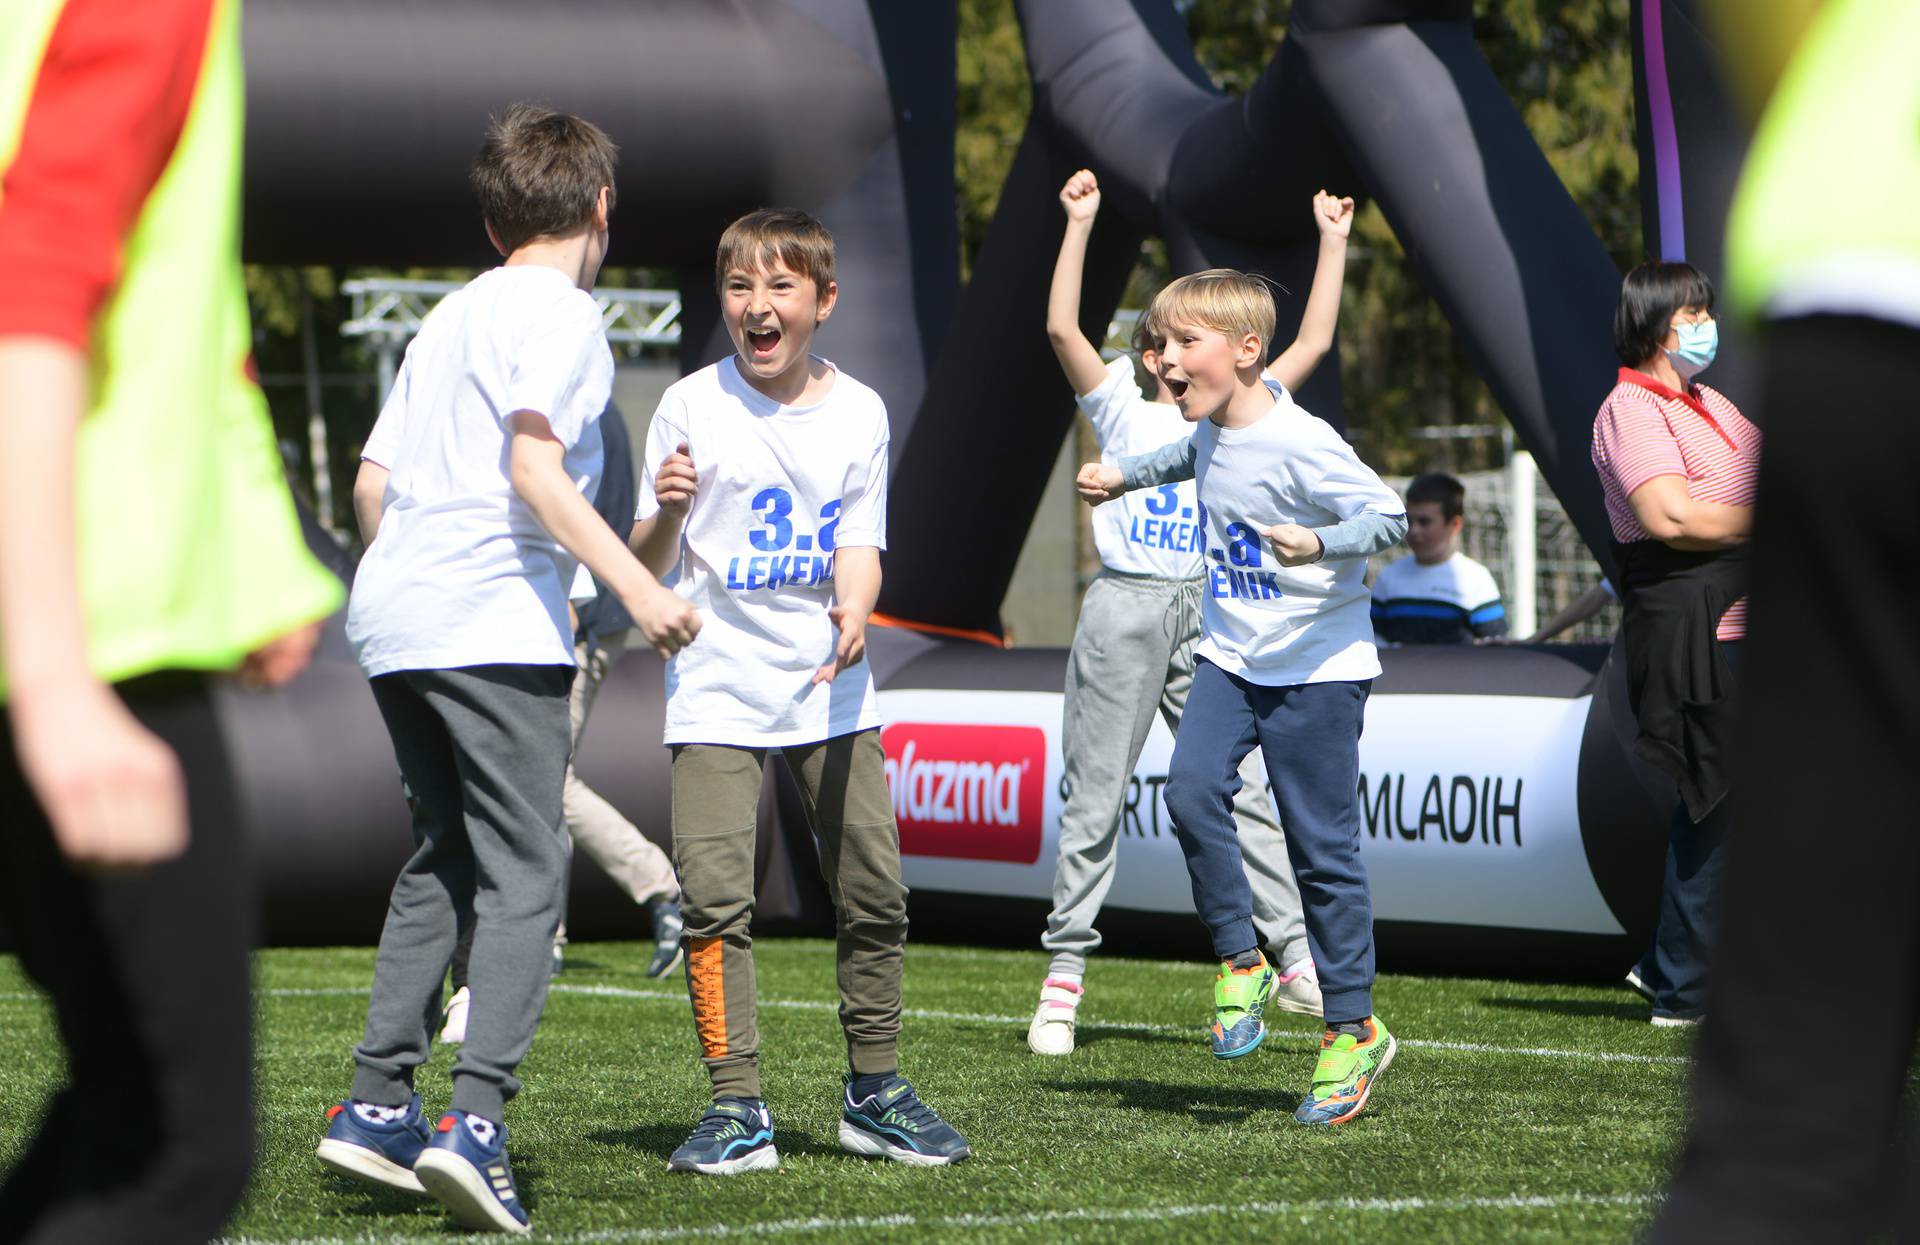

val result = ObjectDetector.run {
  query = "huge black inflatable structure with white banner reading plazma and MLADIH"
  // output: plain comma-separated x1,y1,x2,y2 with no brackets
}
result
225,0,1743,972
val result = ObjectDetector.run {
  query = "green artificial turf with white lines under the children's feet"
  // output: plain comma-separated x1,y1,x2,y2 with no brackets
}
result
0,940,1688,1245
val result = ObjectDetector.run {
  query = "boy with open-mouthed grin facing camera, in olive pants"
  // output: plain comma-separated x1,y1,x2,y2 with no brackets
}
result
632,208,972,1176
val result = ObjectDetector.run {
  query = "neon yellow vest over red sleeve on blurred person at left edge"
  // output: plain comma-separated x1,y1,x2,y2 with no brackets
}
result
0,0,344,694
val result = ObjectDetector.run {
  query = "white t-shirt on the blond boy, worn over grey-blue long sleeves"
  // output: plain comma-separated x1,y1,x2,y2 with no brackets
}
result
1192,390,1405,686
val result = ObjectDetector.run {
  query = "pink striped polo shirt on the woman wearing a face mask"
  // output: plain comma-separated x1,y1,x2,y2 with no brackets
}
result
1594,367,1761,640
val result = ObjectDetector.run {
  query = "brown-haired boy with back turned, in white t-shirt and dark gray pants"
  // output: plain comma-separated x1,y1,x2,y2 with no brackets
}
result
319,104,699,1232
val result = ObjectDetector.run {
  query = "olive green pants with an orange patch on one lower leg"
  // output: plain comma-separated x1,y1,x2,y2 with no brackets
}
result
674,730,906,1097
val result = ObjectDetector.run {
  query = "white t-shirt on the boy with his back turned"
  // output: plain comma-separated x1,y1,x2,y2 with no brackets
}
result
348,263,612,676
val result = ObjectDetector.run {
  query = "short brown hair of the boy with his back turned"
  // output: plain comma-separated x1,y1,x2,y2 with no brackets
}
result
468,102,620,252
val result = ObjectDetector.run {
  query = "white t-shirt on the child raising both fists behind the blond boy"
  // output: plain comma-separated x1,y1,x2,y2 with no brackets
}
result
1075,357,1202,578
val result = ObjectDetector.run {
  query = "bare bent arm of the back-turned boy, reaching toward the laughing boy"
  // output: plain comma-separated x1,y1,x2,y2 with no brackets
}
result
507,411,701,657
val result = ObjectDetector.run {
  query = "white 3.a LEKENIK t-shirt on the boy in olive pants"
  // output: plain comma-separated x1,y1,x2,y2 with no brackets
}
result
636,355,889,747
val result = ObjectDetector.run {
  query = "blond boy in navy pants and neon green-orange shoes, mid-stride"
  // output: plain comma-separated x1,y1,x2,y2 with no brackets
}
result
1077,269,1407,1124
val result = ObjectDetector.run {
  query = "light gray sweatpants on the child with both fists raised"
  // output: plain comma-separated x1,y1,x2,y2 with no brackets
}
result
1041,571,1308,974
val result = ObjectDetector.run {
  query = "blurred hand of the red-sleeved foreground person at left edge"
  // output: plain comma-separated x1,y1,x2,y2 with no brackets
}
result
8,678,186,872
